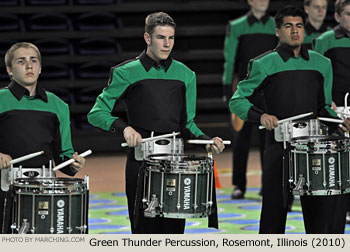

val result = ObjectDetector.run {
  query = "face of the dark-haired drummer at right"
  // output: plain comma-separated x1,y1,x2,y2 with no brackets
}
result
276,16,305,48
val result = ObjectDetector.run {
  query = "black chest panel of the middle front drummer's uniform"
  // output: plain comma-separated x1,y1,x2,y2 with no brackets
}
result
126,79,186,132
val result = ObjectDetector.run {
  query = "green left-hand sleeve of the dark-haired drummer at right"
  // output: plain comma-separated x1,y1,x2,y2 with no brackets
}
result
229,60,267,121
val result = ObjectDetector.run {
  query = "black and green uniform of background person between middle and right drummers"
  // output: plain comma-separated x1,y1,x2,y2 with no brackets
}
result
222,12,278,196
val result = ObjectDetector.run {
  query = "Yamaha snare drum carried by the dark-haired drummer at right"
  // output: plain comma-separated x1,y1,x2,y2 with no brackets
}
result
289,137,350,195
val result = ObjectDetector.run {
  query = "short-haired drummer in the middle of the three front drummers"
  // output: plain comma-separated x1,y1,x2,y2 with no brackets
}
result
88,12,224,233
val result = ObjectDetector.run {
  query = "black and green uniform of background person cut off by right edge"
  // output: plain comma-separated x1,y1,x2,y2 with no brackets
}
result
313,25,350,106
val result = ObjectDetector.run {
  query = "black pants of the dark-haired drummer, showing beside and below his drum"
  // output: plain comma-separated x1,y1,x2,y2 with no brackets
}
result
259,132,348,234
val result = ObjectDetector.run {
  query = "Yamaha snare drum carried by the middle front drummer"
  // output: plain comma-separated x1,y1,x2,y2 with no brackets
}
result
142,154,214,219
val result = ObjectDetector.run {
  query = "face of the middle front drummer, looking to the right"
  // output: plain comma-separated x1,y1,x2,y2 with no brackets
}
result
144,26,175,62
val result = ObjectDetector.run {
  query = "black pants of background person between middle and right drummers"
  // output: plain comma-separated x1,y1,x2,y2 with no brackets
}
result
232,122,266,193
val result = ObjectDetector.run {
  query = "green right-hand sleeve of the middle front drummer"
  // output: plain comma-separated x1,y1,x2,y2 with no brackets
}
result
185,72,204,137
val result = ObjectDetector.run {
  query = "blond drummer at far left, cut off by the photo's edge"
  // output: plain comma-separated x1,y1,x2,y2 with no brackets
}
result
0,42,85,233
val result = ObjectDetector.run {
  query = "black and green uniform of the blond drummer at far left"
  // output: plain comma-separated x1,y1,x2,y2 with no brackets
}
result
0,81,75,232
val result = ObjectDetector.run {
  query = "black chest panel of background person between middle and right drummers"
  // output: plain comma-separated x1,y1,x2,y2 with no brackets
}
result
234,34,278,80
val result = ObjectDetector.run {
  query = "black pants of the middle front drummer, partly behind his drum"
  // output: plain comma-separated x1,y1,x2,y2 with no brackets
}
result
125,148,186,234
